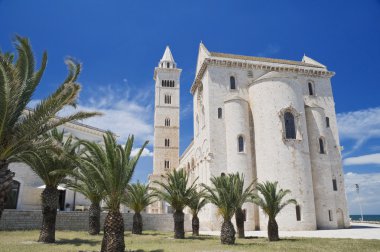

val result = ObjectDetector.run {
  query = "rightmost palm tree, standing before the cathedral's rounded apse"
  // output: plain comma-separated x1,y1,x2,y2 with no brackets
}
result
253,181,297,241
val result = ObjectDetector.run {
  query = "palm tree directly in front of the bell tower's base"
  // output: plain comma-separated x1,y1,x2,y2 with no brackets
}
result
154,169,196,239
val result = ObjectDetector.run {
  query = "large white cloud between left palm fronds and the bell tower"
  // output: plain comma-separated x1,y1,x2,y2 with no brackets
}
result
29,83,153,144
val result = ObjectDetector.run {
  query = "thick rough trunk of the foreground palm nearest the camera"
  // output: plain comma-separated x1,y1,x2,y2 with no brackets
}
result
101,211,125,252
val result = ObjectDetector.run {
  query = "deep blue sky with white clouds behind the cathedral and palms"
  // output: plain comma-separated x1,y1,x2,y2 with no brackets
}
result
0,0,380,214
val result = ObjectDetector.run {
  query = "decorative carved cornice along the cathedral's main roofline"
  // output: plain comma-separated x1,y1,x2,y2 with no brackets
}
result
190,58,335,95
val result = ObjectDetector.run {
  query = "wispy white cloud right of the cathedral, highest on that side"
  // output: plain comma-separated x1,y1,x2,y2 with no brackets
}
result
337,107,380,155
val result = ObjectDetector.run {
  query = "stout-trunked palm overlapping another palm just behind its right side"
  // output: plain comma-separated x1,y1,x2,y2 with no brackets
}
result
202,174,238,244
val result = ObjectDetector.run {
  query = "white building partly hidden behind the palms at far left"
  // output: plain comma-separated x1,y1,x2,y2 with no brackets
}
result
5,119,105,211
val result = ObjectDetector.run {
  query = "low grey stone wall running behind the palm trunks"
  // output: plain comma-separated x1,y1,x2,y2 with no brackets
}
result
0,210,191,231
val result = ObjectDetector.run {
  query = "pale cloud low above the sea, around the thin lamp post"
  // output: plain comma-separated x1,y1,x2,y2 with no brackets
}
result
344,172,380,214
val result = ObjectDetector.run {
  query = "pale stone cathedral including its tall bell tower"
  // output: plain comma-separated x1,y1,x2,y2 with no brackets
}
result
148,43,349,230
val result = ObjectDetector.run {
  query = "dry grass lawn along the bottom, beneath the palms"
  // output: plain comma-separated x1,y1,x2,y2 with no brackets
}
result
0,230,380,252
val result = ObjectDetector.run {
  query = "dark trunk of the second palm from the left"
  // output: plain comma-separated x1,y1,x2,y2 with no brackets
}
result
38,186,59,243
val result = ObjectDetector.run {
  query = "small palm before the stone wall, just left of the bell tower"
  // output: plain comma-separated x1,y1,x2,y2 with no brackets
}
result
124,182,155,234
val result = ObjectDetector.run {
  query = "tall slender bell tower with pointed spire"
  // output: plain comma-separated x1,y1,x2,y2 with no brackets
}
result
149,46,182,213
